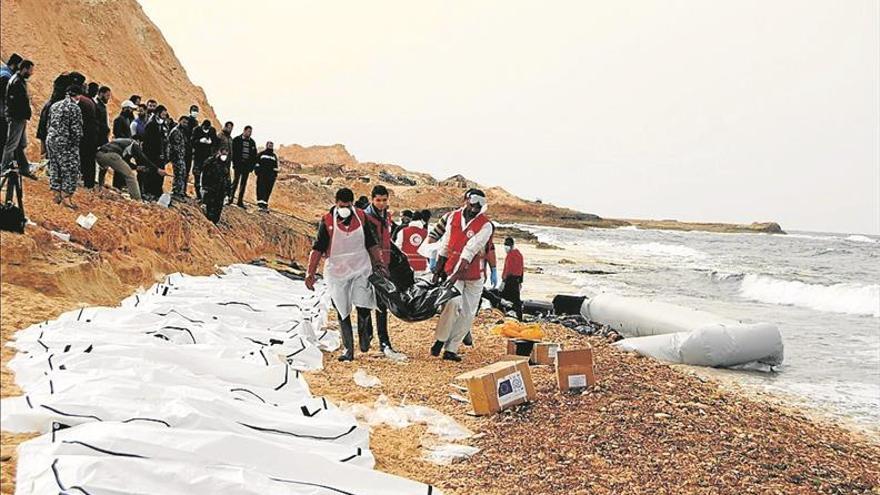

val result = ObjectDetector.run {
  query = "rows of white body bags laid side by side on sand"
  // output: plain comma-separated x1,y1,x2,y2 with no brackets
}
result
0,265,439,495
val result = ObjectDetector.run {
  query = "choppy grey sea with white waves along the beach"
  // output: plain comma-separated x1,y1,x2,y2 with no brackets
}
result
518,225,880,431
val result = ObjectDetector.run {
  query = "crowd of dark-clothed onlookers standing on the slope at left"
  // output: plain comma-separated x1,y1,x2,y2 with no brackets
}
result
0,54,279,223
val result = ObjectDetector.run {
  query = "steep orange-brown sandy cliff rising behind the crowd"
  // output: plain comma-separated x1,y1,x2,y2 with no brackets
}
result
0,0,216,159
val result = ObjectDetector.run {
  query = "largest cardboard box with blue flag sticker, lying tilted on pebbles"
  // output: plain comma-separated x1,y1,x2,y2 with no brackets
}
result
456,358,535,416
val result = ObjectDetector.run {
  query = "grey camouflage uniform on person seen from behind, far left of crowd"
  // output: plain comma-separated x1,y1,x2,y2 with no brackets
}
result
46,98,83,194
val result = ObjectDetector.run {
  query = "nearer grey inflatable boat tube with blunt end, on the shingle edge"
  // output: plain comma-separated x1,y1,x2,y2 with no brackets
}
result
615,323,784,368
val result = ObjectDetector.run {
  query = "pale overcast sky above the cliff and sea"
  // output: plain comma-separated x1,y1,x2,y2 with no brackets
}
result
141,0,880,234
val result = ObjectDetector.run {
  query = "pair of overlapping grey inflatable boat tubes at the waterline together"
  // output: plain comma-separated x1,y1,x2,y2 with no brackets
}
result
581,294,784,368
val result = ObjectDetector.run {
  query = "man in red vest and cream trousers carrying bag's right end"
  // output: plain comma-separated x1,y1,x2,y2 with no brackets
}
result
431,189,494,361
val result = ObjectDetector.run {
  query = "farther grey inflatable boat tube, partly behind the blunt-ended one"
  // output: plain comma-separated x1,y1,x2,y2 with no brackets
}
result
581,294,739,337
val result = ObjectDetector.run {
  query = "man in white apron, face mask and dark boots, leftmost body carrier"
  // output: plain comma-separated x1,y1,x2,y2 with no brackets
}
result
305,188,387,361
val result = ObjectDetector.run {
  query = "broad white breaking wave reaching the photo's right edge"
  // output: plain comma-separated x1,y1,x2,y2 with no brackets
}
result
740,274,880,318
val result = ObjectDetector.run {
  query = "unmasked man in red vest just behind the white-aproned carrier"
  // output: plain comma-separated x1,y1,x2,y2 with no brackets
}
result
358,184,396,354
